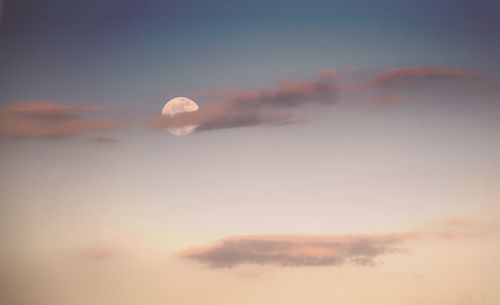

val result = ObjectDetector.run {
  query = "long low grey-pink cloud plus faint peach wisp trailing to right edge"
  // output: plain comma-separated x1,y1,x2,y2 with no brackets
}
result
179,218,499,268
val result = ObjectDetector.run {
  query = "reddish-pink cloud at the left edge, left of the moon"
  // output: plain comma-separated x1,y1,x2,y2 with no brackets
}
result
0,102,128,138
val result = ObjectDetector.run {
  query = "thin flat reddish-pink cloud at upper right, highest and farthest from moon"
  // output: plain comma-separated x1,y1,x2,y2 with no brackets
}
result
369,67,476,88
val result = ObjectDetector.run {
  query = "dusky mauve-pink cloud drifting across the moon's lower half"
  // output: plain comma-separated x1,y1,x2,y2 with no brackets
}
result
151,80,338,132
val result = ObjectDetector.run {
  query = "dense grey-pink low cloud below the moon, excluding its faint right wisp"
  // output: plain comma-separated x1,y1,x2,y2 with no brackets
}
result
180,234,414,268
